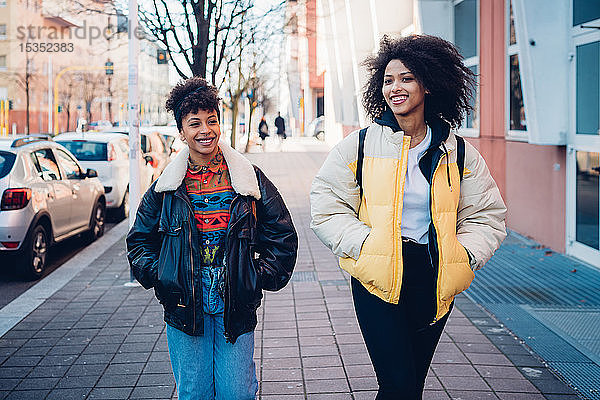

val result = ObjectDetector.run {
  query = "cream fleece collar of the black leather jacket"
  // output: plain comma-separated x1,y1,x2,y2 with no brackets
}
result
154,141,260,200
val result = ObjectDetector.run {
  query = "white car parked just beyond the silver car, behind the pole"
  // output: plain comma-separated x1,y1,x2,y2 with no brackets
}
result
54,132,153,218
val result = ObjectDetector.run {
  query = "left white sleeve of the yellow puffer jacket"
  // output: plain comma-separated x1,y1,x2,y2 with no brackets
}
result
310,144,371,260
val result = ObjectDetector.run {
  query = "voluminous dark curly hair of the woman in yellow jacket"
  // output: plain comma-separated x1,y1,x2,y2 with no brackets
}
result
362,35,476,128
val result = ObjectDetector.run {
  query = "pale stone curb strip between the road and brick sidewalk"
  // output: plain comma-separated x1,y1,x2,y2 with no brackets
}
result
0,219,129,337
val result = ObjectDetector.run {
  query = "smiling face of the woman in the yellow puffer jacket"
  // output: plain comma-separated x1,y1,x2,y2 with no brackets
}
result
381,60,426,119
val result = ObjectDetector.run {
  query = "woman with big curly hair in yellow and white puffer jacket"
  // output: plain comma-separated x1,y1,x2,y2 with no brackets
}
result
311,35,506,400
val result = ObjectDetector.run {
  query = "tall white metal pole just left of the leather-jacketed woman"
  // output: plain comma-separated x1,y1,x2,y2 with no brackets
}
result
128,0,141,227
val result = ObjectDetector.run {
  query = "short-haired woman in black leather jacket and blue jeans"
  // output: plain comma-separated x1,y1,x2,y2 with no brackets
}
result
127,78,298,400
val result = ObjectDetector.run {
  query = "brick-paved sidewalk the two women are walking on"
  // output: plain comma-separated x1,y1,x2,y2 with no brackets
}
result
0,148,576,400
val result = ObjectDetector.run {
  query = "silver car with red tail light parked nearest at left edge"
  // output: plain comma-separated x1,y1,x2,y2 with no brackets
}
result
0,136,106,279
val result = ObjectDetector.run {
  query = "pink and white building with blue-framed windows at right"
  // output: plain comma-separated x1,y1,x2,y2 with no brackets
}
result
317,0,600,267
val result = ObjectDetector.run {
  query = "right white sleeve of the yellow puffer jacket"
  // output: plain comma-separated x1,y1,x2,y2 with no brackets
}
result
456,142,506,270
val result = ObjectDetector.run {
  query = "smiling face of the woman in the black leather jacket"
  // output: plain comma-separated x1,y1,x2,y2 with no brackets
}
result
180,110,221,164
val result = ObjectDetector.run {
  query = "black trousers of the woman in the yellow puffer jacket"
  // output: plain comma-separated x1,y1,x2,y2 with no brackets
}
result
352,242,449,400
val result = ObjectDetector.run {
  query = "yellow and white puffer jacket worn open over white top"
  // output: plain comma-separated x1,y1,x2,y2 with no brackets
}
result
310,115,506,322
